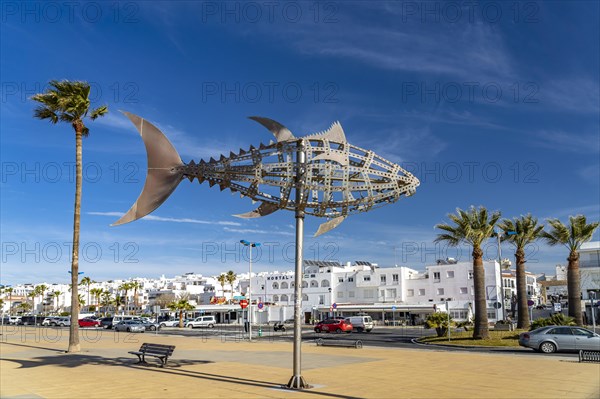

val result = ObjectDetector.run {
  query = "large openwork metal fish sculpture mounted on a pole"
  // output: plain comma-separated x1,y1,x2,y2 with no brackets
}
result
113,112,419,237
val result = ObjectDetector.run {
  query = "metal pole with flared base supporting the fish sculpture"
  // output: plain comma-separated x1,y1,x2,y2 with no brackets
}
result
287,140,310,389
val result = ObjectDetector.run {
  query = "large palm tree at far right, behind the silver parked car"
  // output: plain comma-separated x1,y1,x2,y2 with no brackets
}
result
541,215,598,326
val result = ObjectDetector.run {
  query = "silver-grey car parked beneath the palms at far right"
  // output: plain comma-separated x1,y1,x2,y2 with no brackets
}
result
519,326,600,353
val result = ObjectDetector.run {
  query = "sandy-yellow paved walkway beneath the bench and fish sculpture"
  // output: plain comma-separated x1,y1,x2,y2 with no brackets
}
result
0,327,600,399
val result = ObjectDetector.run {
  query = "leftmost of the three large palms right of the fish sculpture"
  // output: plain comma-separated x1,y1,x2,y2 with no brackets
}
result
435,206,500,339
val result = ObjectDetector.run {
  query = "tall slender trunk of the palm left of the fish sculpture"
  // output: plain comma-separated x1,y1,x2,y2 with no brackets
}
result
67,128,83,353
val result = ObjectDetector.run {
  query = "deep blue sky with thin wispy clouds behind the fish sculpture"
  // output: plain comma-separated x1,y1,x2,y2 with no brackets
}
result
0,1,600,284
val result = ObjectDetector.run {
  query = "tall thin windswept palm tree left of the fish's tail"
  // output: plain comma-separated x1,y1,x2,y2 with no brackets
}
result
31,80,108,353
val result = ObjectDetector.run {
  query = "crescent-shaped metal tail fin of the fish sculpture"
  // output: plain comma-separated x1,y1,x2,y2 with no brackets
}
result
112,111,184,226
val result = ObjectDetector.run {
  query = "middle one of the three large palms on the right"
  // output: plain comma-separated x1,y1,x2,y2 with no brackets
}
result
499,214,544,328
